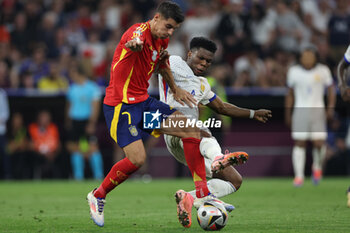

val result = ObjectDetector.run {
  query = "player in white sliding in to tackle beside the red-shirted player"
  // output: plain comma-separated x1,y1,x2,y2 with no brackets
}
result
159,37,272,217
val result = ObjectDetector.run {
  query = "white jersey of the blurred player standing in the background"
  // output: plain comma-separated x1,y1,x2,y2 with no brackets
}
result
287,64,333,108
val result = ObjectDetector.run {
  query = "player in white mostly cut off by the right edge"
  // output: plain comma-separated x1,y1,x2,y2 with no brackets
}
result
337,45,350,208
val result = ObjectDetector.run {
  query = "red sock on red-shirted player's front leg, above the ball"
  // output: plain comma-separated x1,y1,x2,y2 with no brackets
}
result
182,138,209,198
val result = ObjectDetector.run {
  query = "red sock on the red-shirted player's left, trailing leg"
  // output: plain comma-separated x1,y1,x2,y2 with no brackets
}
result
94,158,139,198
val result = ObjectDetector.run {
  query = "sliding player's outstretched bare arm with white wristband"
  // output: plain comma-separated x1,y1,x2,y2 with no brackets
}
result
207,96,272,123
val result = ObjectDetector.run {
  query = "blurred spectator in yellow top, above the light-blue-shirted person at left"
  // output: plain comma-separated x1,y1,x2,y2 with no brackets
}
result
38,62,69,92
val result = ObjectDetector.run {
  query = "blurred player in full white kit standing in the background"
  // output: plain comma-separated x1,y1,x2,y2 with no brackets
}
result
285,45,336,187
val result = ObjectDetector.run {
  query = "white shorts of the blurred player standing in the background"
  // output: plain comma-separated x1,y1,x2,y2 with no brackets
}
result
292,108,327,141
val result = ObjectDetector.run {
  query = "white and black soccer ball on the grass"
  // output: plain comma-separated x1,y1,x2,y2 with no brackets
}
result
197,201,228,231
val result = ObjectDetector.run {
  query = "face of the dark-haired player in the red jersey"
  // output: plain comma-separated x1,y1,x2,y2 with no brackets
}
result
152,14,180,39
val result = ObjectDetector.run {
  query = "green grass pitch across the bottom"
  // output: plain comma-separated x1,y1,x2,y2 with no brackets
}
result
0,178,350,233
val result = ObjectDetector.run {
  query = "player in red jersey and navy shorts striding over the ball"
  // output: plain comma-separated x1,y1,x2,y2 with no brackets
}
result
87,1,226,227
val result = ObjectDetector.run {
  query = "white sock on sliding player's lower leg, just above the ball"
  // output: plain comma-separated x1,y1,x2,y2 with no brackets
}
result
189,178,236,198
